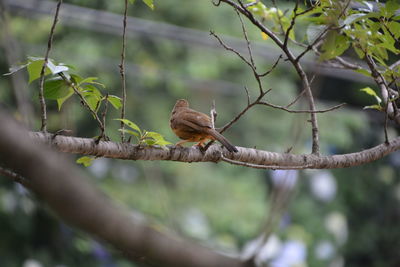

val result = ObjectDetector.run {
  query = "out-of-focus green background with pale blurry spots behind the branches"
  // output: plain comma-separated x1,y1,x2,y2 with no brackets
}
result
0,0,400,267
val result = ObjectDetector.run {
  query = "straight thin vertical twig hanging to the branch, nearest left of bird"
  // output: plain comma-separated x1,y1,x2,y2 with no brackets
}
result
119,0,128,142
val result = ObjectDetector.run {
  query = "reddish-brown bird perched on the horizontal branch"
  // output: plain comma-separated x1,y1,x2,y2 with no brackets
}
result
170,99,238,152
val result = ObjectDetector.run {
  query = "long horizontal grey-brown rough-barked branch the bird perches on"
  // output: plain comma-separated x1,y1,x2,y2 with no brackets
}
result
30,132,400,169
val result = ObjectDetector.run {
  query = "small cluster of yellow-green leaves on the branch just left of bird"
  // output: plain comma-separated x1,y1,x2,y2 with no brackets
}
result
115,119,171,148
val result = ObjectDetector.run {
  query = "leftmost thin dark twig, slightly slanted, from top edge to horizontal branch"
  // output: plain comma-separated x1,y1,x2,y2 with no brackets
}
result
39,0,62,132
